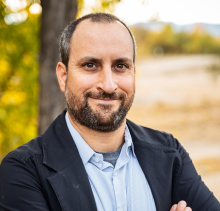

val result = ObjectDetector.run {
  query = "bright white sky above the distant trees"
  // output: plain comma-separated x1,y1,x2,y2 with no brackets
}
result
85,0,220,25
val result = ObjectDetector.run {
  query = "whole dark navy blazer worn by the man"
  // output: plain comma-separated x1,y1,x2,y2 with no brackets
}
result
0,111,220,211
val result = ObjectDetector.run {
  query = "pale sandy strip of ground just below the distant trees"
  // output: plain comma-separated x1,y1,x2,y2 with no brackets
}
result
135,55,220,105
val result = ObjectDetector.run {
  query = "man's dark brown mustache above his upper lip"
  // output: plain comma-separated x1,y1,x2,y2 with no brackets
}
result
85,91,125,100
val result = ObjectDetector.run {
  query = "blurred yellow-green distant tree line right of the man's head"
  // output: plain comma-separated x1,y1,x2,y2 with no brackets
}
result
132,24,220,56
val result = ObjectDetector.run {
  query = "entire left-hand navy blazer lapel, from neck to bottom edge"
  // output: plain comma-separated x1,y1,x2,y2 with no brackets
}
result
43,111,97,211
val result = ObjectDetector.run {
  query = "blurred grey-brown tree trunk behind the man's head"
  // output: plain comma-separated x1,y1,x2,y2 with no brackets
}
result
38,0,77,135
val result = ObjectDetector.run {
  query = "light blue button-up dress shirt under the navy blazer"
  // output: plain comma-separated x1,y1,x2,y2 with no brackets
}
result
65,113,156,211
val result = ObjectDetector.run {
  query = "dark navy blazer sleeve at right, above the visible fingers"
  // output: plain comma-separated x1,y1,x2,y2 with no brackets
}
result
172,137,220,211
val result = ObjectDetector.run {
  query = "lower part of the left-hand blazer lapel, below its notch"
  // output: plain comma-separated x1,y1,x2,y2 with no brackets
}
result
48,159,97,211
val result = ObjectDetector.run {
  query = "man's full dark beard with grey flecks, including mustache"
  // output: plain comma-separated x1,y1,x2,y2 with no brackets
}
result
65,83,135,132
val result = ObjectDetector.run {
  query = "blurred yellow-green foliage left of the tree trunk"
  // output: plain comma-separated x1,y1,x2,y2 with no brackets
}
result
0,1,40,157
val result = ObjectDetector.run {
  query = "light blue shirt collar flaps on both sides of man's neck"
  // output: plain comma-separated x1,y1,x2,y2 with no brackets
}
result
65,112,136,166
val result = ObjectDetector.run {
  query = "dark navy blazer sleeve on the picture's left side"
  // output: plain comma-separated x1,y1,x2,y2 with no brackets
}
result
0,153,50,211
